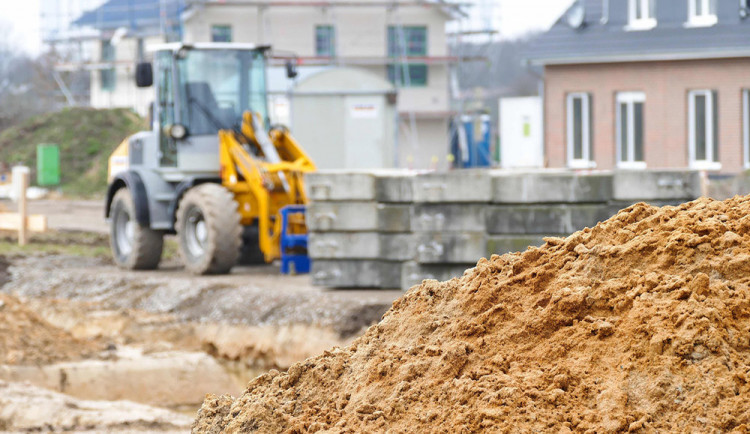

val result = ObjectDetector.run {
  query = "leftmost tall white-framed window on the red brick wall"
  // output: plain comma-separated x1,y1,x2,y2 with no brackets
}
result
567,93,595,168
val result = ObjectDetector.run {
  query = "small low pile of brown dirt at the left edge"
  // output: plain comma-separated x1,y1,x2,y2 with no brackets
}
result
0,293,98,365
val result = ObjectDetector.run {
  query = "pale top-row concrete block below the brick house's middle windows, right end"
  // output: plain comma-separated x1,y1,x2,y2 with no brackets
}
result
614,170,701,202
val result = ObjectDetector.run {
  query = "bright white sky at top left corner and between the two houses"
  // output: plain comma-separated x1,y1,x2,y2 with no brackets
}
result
0,0,573,54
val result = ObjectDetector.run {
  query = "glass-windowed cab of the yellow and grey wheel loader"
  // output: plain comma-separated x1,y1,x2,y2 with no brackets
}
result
136,43,268,175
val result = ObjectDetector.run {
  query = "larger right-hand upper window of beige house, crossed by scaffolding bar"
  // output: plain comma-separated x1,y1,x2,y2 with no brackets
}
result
387,26,427,87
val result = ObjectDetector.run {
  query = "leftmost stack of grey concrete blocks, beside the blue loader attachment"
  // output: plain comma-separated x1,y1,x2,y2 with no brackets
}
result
306,171,415,288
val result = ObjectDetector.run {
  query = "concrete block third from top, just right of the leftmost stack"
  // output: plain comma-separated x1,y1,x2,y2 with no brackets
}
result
416,232,486,264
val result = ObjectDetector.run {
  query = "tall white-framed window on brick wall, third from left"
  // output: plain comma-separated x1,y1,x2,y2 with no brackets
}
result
688,90,721,169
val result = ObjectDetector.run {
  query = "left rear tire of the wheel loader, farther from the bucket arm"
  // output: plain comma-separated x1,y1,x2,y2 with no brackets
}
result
109,188,164,270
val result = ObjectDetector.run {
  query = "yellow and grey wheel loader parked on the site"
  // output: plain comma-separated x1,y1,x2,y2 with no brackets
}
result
105,43,315,274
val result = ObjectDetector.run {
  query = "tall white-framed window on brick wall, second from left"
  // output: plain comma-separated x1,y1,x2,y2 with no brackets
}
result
615,92,646,169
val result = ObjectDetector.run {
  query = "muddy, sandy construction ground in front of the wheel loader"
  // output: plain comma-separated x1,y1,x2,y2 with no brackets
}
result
0,200,402,432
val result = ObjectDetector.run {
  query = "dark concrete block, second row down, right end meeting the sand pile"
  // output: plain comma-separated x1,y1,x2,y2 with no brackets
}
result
487,204,612,235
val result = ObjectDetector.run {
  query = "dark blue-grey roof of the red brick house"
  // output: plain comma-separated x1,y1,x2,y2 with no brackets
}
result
526,0,750,64
